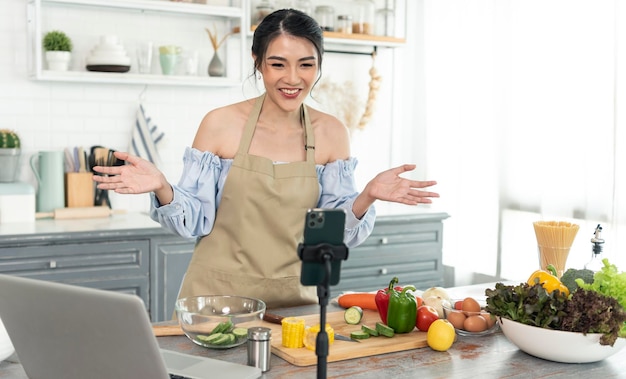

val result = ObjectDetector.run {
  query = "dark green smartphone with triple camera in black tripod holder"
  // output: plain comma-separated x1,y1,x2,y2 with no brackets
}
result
298,208,347,286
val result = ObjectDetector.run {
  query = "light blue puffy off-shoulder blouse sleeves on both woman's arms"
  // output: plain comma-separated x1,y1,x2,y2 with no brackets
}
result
150,147,376,247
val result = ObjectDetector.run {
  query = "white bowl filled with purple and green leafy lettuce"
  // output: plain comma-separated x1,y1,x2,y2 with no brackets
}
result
485,259,626,363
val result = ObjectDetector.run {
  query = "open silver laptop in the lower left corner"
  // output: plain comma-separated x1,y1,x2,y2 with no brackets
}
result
0,275,262,379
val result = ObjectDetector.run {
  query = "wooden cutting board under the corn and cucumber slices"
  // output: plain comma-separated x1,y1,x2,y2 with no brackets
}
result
263,309,428,366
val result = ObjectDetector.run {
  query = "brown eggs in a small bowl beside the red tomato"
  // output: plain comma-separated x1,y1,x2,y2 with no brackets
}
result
443,299,499,336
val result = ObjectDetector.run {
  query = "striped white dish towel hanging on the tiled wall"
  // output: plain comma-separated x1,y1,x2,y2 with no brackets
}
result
130,105,164,167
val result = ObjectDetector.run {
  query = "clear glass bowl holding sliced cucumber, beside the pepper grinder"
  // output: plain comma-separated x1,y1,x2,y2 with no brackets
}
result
175,295,265,349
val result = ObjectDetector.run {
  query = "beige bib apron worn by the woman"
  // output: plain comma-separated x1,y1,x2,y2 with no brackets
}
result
179,95,319,308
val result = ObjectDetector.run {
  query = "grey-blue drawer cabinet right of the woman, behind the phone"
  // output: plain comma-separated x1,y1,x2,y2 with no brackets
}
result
331,213,448,296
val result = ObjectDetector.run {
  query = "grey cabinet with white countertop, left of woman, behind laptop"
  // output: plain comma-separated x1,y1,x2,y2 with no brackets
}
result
0,214,194,321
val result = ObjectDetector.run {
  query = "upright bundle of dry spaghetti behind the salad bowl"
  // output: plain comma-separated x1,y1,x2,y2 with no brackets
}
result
533,221,579,277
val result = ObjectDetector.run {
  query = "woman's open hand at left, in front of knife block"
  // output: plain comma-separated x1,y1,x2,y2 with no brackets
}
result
93,151,174,204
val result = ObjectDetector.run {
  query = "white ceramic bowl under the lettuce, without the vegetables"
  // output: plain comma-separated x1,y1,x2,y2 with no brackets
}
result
498,317,626,363
